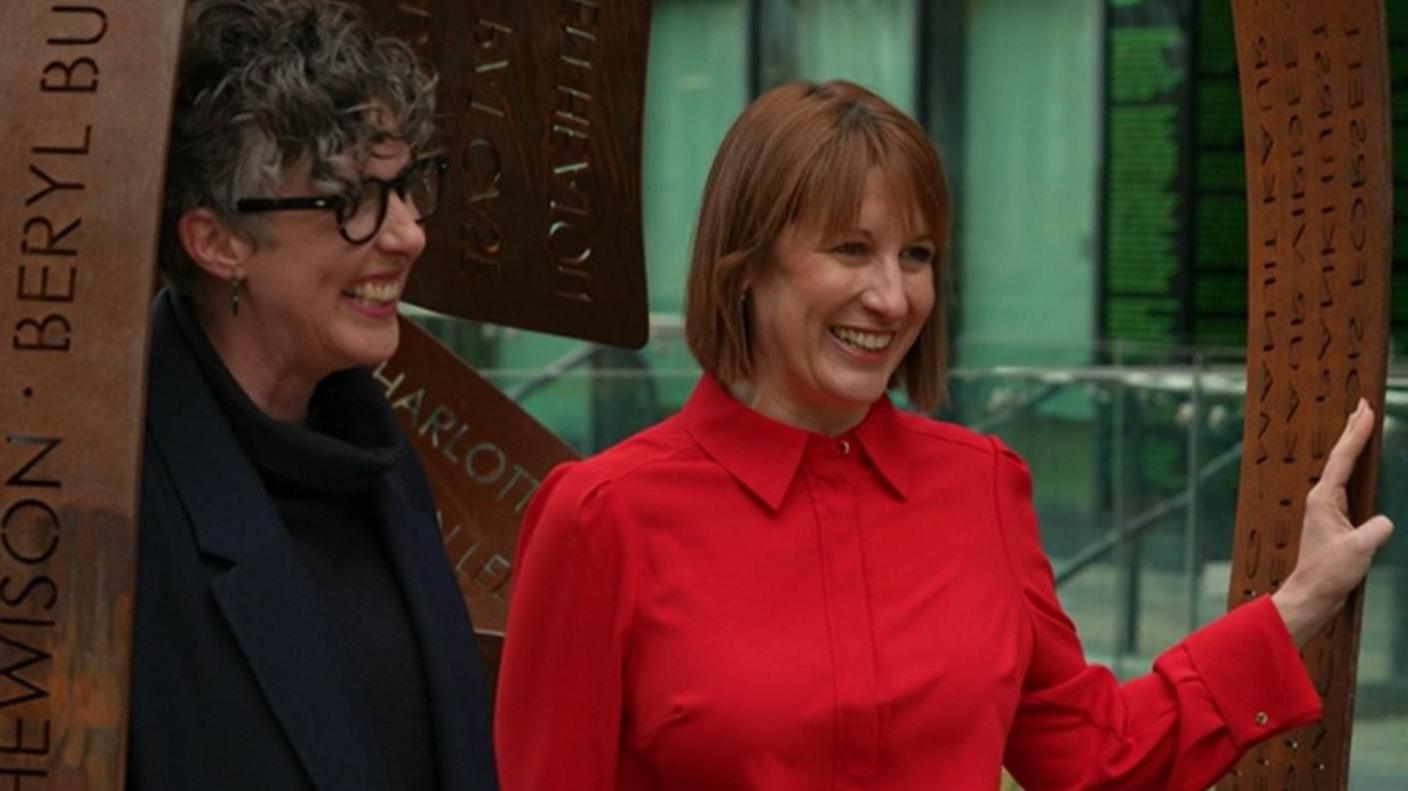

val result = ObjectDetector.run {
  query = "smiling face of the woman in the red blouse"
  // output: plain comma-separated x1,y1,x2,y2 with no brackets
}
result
741,170,936,436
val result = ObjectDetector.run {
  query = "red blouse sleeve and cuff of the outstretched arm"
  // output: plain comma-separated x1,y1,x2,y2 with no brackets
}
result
994,441,1321,791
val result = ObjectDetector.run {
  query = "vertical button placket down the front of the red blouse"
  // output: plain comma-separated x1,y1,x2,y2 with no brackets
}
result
805,443,880,791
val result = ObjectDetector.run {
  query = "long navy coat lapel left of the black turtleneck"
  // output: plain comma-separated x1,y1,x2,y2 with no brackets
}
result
148,293,386,791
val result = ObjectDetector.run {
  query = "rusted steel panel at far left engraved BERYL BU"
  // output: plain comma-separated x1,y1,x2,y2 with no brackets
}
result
0,0,182,791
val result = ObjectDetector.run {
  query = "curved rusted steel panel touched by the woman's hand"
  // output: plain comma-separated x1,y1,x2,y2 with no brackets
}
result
1221,0,1393,790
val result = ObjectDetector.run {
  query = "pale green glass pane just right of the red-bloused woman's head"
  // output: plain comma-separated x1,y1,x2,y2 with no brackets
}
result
963,0,1102,365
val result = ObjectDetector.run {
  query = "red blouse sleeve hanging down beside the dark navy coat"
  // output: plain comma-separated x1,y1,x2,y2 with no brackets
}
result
494,463,636,791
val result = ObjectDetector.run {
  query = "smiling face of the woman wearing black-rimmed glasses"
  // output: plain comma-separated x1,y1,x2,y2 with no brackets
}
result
230,141,425,383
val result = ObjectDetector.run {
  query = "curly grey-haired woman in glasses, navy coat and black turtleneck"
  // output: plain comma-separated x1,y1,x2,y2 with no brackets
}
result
128,0,494,791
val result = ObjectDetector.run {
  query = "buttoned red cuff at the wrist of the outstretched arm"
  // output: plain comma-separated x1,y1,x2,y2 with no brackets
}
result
1183,595,1322,746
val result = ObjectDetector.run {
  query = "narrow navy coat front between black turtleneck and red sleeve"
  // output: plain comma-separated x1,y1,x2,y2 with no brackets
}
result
380,472,496,791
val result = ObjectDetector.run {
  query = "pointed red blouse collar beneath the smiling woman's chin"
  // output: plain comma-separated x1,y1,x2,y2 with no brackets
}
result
681,374,911,511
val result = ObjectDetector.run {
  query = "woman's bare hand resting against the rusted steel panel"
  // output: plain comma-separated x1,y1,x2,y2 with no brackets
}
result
1271,398,1394,646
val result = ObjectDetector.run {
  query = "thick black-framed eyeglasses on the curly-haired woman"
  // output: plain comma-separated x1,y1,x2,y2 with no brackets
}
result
235,156,449,245
